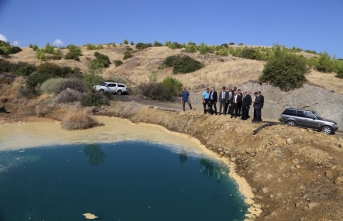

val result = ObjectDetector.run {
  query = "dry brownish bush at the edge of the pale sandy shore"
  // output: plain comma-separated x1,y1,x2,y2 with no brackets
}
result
62,110,99,130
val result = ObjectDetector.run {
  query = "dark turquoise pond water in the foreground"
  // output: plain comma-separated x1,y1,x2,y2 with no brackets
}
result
0,142,247,221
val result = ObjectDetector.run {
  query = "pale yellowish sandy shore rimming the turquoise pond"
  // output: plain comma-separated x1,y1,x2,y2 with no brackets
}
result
0,117,262,220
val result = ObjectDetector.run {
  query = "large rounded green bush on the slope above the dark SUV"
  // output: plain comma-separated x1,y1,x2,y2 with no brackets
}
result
260,46,309,91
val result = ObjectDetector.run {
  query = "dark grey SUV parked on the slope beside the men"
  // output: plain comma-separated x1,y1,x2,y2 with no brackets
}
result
279,108,338,134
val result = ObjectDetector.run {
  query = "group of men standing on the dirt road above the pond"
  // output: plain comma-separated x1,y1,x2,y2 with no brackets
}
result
181,87,264,121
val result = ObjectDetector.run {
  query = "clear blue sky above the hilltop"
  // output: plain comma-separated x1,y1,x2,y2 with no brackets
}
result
0,0,343,58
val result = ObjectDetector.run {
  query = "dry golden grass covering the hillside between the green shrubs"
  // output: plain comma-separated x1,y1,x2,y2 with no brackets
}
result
6,45,343,94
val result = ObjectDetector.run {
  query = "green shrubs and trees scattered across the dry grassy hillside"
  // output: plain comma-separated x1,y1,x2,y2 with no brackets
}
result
0,39,343,109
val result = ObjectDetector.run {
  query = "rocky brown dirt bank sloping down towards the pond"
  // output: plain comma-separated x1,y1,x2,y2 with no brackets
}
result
0,102,343,221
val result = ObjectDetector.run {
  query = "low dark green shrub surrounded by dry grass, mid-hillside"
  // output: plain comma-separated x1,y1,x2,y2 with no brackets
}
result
163,55,204,74
